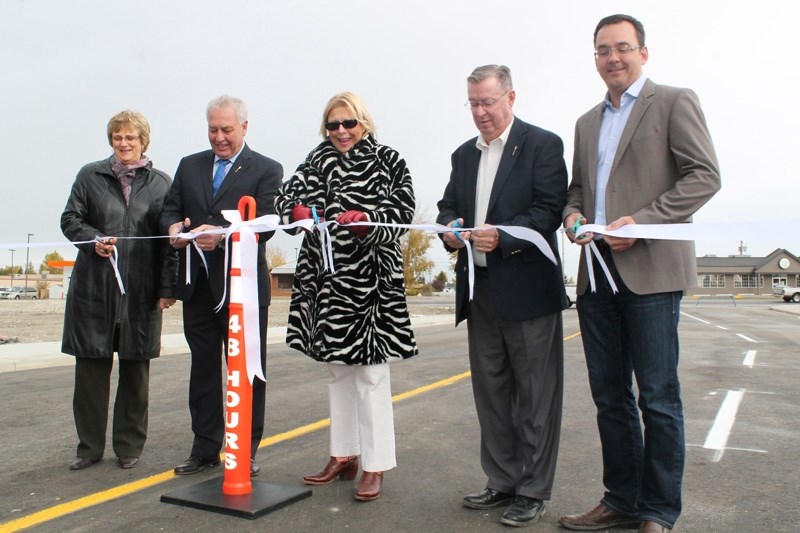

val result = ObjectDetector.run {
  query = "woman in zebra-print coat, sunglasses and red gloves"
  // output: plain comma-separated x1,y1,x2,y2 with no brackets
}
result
275,92,417,501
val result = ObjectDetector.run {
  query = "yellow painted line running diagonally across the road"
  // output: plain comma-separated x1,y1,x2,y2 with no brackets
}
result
0,331,580,533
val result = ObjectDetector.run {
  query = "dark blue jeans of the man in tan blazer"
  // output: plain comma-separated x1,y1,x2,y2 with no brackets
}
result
578,254,686,528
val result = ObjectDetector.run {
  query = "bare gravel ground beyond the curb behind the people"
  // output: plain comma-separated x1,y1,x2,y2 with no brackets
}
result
0,297,453,342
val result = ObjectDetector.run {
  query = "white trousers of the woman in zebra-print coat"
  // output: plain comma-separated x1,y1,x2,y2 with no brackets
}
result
328,363,397,472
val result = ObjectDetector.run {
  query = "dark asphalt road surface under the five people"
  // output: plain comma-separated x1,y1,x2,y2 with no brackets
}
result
0,299,800,533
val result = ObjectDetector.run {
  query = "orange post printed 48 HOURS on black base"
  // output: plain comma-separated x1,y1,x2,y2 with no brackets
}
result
222,196,258,495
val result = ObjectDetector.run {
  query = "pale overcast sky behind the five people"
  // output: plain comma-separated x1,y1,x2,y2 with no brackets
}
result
0,0,800,275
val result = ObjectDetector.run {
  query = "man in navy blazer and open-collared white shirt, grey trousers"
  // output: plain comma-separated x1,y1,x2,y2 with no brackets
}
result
437,65,567,526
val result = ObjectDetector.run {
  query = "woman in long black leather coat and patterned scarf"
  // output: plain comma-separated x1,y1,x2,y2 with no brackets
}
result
61,111,177,470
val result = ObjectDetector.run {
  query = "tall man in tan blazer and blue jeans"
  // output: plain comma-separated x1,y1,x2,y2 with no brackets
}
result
560,15,720,533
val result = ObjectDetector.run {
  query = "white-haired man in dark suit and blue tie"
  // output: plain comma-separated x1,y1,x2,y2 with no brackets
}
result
161,96,283,475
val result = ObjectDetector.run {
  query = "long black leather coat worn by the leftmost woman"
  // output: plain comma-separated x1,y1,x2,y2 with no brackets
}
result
61,159,178,359
